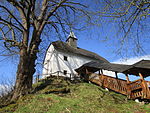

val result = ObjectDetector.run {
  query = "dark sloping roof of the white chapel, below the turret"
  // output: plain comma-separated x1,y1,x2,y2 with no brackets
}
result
52,41,108,62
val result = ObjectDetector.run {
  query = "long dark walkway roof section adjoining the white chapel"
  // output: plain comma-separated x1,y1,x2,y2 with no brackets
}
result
76,61,129,73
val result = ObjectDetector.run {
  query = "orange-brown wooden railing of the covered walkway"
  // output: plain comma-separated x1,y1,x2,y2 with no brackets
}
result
89,73,150,99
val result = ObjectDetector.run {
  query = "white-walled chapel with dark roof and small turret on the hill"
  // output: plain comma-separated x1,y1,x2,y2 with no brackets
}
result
42,32,108,78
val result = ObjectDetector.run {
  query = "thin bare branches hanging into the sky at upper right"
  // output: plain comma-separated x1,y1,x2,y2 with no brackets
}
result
95,0,150,53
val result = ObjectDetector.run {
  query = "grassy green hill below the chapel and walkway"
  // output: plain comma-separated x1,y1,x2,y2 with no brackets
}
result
0,77,150,113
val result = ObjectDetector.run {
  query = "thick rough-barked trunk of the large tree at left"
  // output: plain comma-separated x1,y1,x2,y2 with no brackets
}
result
11,48,37,101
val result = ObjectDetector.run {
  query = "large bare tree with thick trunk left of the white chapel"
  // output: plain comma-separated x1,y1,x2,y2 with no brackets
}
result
0,0,88,101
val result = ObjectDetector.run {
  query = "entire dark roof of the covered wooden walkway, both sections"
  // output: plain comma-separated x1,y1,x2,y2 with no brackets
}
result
76,60,150,77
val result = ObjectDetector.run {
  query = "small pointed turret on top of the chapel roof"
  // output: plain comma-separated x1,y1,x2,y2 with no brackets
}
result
66,31,78,48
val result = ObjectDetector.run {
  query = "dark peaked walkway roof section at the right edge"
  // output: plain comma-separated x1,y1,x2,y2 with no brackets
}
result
122,60,150,77
